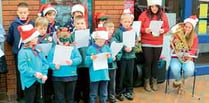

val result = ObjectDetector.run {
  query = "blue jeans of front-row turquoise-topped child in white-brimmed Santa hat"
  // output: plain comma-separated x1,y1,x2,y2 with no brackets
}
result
89,81,108,103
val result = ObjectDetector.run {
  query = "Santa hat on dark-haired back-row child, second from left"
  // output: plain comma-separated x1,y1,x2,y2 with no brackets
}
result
38,4,57,16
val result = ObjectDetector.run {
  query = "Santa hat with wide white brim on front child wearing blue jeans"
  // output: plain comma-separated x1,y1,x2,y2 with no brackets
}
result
91,27,108,40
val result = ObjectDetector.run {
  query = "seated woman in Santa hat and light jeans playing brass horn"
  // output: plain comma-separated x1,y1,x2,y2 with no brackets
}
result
170,16,198,92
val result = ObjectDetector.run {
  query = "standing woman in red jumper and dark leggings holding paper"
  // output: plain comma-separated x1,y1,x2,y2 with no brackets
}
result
138,0,169,92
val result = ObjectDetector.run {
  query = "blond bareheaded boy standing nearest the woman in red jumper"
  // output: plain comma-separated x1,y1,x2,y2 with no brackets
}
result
115,13,136,101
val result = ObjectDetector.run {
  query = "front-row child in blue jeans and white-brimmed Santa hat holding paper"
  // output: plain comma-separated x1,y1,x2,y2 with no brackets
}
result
85,31,113,103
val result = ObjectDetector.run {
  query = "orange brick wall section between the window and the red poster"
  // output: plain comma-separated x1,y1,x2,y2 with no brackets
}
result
93,0,125,28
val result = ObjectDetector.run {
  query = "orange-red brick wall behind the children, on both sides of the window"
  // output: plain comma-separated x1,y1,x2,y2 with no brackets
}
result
0,0,124,100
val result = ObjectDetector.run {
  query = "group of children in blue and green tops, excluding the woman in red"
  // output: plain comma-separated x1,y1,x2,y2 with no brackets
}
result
7,2,135,103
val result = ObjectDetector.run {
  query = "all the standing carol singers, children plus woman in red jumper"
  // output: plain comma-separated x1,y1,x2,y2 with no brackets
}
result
4,0,199,103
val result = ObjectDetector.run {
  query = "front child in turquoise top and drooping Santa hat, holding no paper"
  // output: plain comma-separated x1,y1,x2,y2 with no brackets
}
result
18,25,49,103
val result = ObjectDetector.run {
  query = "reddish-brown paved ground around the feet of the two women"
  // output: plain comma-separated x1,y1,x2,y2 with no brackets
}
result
0,76,209,103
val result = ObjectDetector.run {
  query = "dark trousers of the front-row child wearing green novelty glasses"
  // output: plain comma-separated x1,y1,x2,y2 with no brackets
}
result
53,81,76,103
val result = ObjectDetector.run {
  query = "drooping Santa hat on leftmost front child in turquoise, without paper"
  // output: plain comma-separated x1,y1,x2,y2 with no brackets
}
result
18,24,40,43
